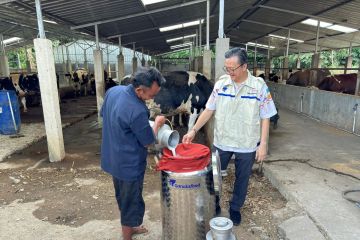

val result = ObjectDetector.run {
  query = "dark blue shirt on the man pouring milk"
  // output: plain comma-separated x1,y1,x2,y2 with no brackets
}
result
100,85,155,181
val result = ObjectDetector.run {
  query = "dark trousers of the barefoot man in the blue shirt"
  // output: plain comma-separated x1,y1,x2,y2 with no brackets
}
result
113,177,145,227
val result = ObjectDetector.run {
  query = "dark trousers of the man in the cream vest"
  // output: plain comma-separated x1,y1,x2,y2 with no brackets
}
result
217,148,256,211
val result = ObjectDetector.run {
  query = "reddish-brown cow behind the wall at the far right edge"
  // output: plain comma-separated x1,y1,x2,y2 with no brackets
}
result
317,73,357,94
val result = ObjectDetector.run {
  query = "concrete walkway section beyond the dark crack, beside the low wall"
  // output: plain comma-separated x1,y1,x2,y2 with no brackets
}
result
269,109,360,178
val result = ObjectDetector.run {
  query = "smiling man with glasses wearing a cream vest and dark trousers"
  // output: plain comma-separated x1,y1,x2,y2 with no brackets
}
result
183,48,277,225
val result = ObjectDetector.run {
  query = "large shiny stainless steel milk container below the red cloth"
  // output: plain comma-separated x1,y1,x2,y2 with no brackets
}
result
161,159,221,240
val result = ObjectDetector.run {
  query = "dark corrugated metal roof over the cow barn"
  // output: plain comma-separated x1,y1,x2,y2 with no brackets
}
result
0,0,360,55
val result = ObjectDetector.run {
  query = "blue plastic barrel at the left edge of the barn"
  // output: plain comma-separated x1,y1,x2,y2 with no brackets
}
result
0,90,21,135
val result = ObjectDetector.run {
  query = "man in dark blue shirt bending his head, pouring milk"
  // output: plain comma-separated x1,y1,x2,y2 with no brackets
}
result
100,68,165,240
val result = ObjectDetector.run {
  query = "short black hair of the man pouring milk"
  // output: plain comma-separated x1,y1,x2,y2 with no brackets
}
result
132,67,166,88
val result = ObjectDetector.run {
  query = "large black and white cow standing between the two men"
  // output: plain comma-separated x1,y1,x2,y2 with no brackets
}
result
121,71,214,129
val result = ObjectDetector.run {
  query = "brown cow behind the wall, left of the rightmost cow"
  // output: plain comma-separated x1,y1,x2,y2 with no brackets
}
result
286,69,331,87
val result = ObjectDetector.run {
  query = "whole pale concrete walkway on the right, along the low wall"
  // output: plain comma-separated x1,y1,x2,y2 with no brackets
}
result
264,109,360,240
